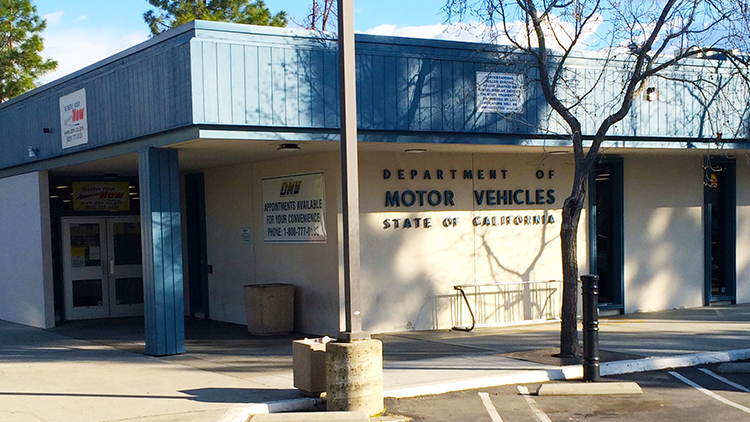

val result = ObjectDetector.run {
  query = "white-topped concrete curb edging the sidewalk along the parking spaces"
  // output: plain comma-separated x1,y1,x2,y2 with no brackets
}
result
219,349,750,422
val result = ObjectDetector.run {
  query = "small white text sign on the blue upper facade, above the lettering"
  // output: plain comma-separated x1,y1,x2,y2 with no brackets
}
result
477,72,524,113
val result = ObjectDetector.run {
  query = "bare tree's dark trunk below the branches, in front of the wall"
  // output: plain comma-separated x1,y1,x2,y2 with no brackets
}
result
560,163,588,358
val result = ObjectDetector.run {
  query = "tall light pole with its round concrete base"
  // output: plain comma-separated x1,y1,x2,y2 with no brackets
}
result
326,0,384,416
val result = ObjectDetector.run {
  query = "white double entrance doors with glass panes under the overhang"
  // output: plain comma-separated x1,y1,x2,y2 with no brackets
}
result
62,217,143,320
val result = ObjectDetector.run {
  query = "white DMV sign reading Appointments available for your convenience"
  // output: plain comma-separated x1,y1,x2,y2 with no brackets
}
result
262,172,327,243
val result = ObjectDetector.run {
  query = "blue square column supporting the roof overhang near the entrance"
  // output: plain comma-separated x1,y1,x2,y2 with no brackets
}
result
138,148,185,356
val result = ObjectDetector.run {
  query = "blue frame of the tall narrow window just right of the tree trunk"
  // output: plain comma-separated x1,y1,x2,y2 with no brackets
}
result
588,157,625,312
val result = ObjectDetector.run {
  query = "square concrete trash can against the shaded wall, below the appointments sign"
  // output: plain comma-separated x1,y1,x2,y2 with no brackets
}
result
245,283,294,336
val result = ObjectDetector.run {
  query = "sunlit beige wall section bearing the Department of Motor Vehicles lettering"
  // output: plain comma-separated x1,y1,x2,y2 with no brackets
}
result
360,153,586,332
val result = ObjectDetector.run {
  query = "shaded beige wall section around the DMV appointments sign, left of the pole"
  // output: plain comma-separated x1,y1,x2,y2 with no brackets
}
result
205,154,340,335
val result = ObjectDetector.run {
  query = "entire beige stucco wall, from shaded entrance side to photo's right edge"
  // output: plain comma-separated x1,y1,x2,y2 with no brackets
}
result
200,148,750,335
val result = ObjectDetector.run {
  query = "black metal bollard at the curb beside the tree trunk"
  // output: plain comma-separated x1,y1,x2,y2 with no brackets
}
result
581,274,600,381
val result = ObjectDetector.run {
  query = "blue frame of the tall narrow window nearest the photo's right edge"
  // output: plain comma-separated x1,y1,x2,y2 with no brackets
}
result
703,156,737,306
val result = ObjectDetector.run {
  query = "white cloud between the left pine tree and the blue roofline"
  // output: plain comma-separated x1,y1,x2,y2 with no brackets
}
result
39,27,148,84
